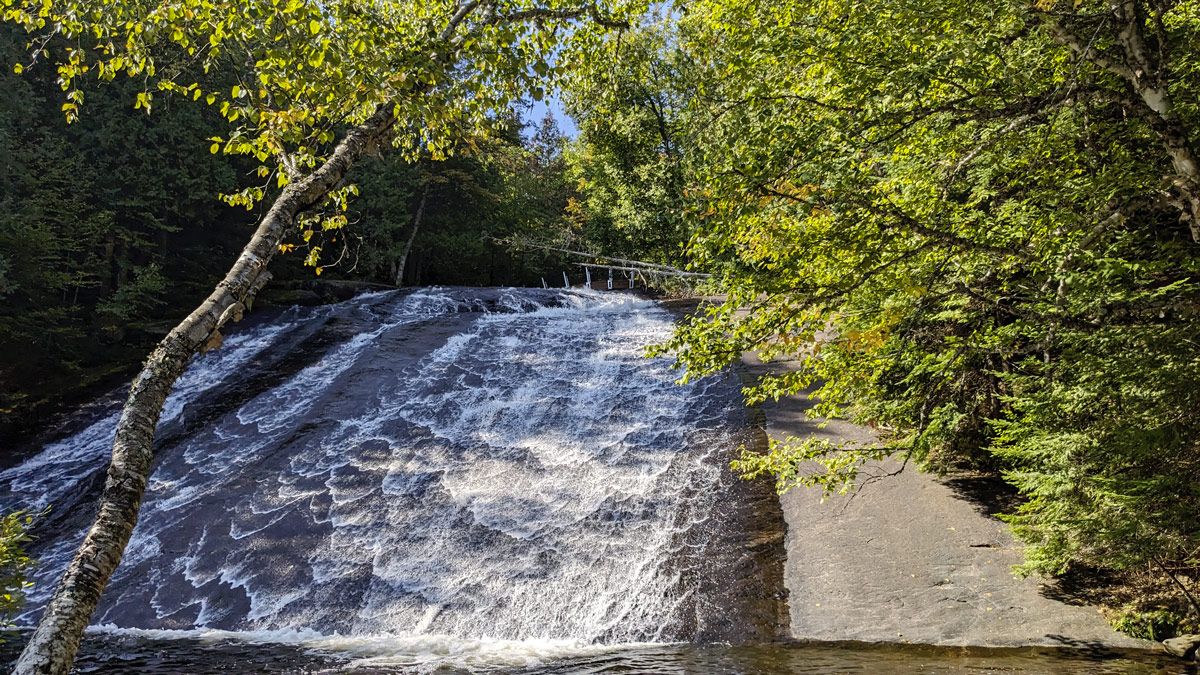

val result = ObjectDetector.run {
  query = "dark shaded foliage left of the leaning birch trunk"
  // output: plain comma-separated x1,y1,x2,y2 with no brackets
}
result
0,25,246,425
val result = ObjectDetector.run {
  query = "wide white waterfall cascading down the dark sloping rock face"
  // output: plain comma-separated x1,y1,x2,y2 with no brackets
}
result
0,289,778,662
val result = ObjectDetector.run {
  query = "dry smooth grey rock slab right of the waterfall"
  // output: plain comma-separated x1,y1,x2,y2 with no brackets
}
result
744,357,1157,649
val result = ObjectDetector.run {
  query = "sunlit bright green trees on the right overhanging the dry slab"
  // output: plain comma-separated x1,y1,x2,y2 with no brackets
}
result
568,0,1200,616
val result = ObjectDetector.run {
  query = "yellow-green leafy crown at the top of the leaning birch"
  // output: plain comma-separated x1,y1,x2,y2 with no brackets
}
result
4,0,636,260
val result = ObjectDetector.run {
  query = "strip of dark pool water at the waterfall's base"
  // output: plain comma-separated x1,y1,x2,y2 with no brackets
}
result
0,632,1200,675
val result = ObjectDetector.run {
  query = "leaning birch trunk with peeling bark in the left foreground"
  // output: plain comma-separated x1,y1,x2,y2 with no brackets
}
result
13,109,394,675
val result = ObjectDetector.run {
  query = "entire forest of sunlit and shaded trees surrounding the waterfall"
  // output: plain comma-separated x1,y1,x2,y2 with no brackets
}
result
0,0,1200,667
